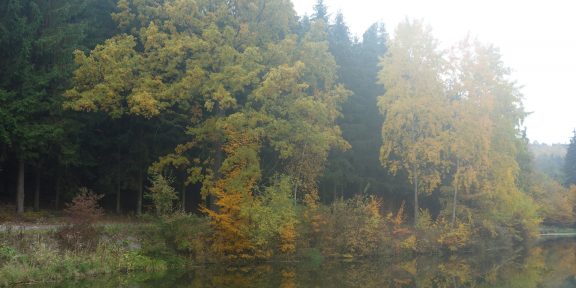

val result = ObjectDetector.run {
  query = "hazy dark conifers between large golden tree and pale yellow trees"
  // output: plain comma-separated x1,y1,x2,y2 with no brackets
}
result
320,13,394,205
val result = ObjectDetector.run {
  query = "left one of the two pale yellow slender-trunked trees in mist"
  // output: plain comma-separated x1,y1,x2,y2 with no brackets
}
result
378,20,450,222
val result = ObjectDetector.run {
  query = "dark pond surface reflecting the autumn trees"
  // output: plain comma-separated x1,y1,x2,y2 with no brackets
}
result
42,238,576,288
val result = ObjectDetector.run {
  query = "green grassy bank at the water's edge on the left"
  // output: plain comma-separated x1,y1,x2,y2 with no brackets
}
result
0,228,167,287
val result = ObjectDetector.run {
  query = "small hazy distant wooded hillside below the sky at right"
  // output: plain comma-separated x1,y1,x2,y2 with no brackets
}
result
529,143,568,183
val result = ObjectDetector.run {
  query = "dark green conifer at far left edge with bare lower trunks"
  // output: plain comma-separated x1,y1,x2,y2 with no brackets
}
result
0,0,100,213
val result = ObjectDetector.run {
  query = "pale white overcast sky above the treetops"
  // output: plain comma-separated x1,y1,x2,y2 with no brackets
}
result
292,0,576,144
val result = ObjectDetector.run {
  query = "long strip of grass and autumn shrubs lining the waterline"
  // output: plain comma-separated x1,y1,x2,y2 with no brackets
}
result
0,193,540,286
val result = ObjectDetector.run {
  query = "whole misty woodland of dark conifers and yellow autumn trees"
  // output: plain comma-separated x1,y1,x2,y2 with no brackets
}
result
0,0,576,258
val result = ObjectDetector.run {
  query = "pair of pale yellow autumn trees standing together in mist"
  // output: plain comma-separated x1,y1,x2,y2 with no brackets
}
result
378,21,539,240
